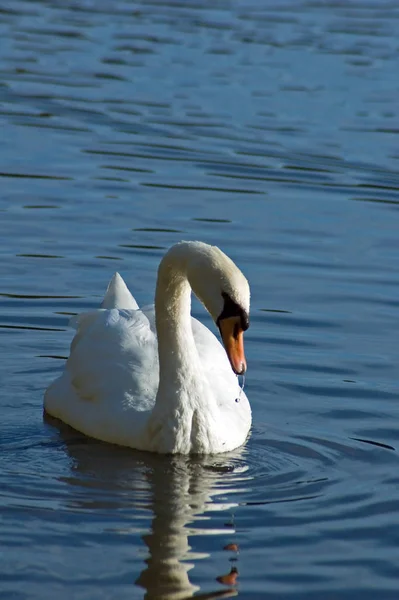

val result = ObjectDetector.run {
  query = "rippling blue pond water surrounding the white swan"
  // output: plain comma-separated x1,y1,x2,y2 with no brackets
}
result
0,0,399,600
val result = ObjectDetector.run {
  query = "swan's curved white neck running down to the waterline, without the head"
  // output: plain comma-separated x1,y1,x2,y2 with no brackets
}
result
150,245,219,454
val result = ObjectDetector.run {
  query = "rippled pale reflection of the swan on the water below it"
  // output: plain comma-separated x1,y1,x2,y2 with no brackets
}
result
51,420,248,600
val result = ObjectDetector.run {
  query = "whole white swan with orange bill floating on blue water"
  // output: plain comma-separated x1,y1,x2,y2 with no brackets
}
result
44,242,251,454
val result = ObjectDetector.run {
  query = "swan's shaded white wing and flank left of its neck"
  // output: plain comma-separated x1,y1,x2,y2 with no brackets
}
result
44,308,159,447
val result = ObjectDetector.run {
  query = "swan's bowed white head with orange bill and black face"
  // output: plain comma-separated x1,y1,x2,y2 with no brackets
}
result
179,242,250,375
